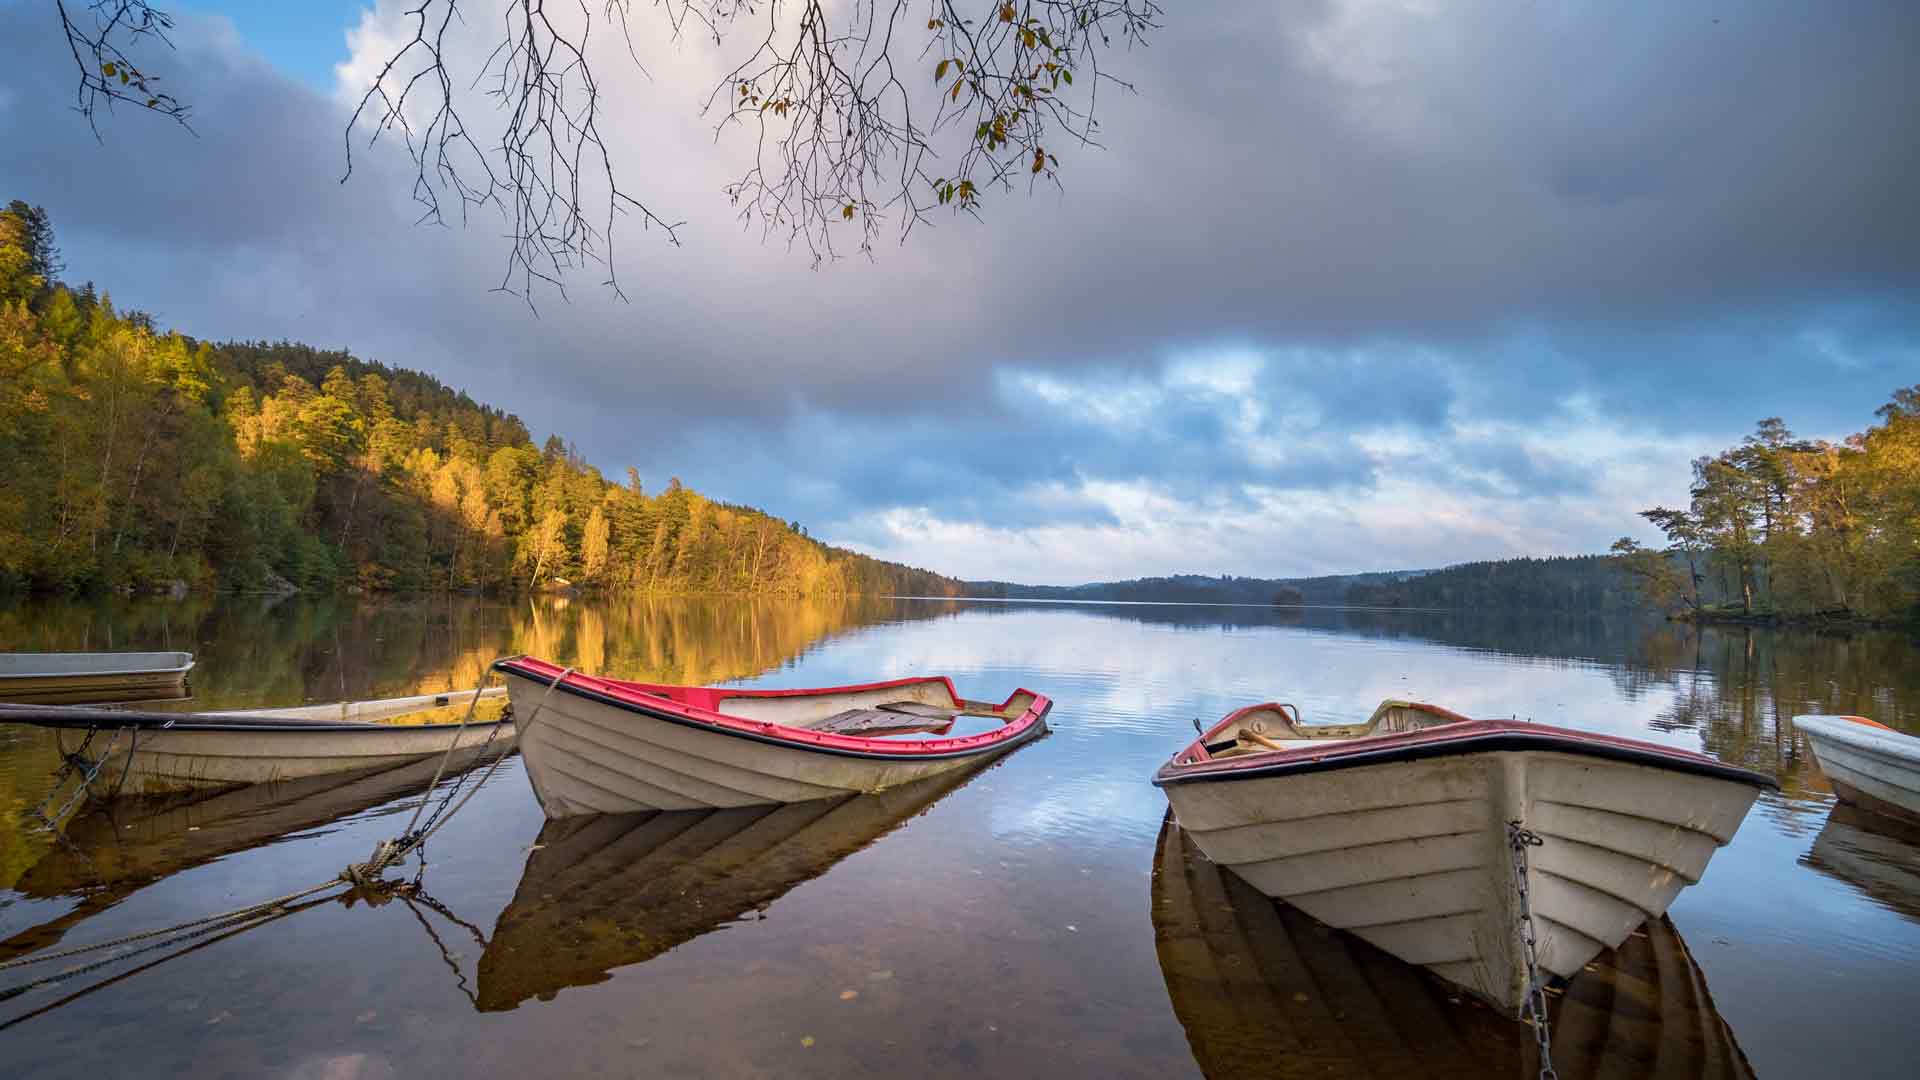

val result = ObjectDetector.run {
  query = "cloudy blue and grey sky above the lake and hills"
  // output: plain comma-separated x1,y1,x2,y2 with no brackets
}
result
0,0,1920,584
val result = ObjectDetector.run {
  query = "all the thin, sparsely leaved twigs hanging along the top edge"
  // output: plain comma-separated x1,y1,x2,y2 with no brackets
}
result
58,0,1162,304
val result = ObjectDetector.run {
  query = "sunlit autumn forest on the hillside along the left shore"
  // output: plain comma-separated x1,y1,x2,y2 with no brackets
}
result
0,202,960,596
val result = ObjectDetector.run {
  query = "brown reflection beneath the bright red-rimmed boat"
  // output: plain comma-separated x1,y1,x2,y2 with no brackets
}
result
476,769,979,1013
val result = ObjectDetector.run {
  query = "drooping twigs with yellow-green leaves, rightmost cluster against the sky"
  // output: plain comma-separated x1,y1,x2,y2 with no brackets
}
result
708,0,1160,258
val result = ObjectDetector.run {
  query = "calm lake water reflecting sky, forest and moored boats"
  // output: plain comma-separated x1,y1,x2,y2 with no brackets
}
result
0,598,1920,1078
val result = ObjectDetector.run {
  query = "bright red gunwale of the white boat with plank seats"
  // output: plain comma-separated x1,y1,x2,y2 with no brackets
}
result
493,655,1054,761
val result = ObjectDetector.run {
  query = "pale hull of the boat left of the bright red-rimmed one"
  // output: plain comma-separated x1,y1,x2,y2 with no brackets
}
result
0,688,515,796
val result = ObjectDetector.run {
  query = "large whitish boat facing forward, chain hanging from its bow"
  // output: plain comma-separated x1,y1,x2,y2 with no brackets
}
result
1154,701,1774,1013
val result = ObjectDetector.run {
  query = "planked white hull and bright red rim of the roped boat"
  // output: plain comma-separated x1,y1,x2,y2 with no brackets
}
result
497,661,1050,819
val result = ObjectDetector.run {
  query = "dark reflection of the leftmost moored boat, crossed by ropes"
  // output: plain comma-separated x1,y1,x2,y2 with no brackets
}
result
0,748,499,959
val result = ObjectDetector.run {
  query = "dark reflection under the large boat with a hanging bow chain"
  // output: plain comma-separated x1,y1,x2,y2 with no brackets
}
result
1154,817,1753,1080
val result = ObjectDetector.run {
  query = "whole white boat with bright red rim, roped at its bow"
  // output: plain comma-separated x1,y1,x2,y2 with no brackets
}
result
493,657,1052,819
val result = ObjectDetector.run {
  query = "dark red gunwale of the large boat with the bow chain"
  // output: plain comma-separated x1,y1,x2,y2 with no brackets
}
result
1154,721,1780,788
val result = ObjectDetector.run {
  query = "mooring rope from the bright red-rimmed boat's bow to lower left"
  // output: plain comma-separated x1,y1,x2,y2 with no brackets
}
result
0,665,574,999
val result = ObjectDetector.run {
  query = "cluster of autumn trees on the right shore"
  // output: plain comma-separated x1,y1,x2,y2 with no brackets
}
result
1613,399,1920,623
